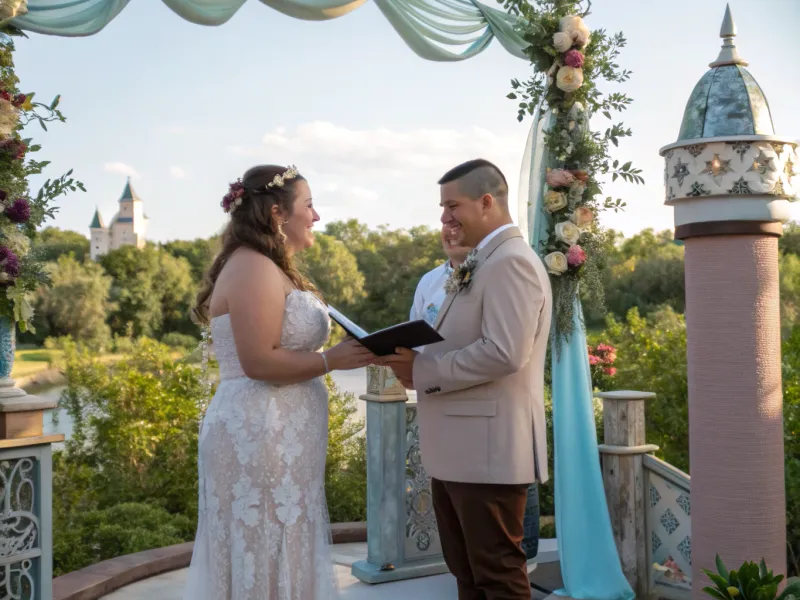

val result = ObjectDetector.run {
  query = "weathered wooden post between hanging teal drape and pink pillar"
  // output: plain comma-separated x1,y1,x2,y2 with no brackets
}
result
597,391,658,600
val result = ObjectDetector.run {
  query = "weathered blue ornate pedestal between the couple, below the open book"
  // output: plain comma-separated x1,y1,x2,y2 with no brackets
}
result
352,366,447,583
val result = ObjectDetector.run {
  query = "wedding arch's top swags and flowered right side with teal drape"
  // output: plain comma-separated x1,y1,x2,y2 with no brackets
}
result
0,0,642,600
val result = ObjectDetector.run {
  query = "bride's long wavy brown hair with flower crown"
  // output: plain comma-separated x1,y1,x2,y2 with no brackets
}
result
193,165,316,324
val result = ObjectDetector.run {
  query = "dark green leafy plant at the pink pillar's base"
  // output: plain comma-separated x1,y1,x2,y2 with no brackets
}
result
703,554,800,600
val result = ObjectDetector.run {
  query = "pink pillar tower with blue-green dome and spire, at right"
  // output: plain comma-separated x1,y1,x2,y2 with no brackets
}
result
660,8,800,600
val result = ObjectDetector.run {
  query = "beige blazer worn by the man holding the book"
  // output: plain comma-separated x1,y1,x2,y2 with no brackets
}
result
414,227,552,484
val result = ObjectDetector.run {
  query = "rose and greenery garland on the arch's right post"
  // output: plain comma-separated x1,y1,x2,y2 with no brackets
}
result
499,0,644,342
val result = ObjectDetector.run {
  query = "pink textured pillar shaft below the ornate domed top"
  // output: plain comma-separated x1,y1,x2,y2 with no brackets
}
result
676,229,786,600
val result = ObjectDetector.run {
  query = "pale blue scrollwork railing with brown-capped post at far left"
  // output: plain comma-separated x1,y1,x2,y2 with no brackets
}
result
0,380,64,600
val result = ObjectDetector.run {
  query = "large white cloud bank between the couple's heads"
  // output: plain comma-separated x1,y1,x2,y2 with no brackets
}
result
228,121,527,228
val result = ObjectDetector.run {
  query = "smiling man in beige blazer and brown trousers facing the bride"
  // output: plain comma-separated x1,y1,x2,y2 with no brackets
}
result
385,159,552,600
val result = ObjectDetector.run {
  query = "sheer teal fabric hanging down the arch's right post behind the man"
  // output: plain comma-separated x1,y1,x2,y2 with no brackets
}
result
519,112,634,600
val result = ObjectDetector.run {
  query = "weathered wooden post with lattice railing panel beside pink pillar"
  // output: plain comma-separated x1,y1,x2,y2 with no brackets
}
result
597,391,692,600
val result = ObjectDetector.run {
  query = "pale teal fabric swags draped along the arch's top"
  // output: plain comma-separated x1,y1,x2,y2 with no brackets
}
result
11,0,527,61
